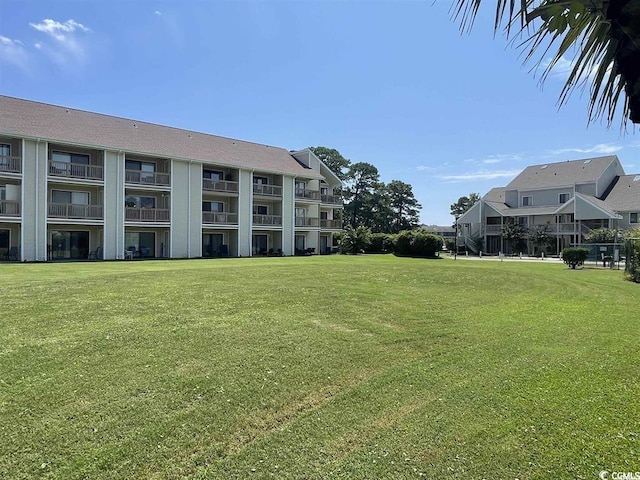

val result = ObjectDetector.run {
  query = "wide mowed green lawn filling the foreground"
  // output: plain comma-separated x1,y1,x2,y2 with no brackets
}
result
0,256,640,480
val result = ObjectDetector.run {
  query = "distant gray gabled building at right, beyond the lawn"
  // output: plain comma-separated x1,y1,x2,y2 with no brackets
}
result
458,155,640,254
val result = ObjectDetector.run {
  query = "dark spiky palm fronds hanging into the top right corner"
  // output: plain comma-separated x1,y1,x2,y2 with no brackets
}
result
453,0,640,125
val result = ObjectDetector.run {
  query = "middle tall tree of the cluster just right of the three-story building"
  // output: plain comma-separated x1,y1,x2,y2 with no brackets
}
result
344,162,380,228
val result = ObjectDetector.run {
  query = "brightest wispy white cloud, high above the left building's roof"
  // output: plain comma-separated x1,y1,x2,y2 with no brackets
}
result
29,18,91,64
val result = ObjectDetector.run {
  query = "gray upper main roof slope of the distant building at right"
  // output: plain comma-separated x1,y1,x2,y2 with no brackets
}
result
506,155,619,190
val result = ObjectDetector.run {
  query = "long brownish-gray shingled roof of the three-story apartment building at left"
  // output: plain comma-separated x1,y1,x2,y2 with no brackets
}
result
0,95,321,178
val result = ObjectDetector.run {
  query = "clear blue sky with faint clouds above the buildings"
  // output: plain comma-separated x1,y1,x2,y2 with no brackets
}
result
0,0,640,225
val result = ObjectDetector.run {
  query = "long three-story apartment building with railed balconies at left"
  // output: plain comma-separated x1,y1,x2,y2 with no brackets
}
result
0,96,342,261
